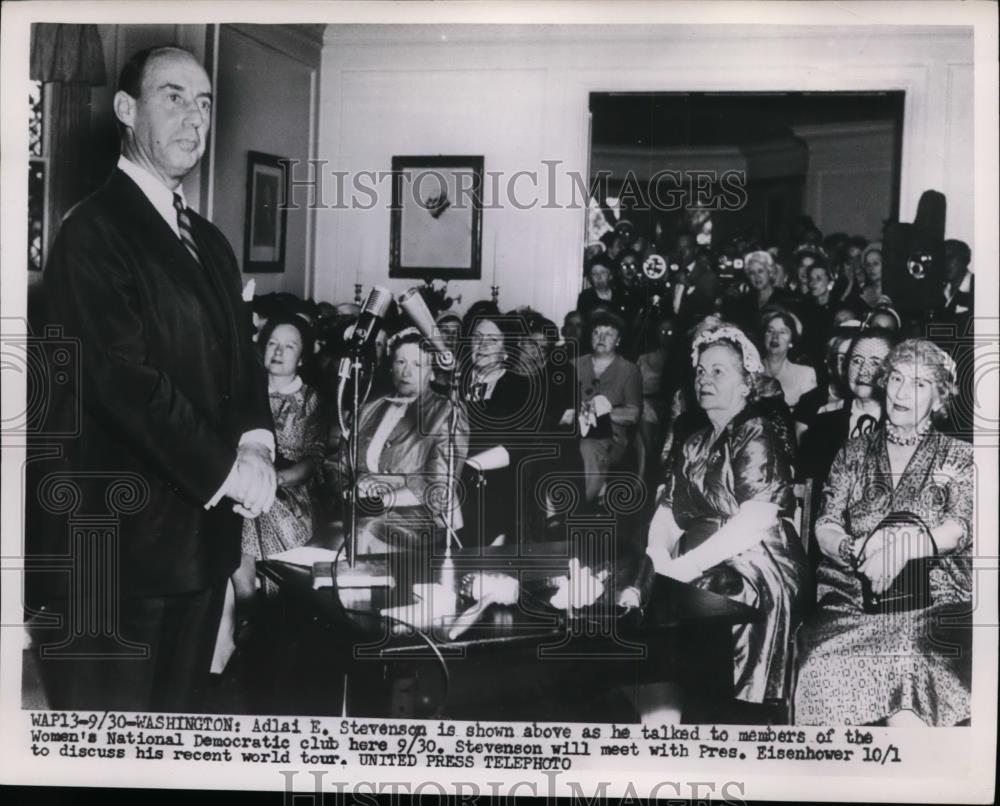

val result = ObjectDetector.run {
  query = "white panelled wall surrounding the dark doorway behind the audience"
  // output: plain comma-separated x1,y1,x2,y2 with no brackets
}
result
313,25,973,324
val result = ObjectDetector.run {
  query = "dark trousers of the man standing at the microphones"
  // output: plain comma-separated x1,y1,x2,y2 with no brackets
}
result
34,584,225,712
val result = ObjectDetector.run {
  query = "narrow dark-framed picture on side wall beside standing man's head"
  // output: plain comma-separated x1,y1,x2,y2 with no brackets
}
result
243,151,288,273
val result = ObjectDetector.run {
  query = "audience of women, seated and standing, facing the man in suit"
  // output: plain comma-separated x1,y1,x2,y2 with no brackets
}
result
242,208,973,725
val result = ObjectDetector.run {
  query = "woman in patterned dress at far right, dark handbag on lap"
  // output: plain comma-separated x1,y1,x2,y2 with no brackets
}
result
795,339,975,726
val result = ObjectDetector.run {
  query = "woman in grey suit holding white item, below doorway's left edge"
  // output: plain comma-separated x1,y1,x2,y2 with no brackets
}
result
563,309,642,503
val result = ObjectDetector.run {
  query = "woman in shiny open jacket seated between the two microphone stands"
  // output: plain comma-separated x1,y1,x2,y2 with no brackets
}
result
341,328,469,553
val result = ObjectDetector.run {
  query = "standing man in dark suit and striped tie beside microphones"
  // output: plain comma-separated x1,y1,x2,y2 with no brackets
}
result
29,47,275,711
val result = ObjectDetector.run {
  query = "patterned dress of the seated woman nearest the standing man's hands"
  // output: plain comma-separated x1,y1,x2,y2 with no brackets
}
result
242,381,326,560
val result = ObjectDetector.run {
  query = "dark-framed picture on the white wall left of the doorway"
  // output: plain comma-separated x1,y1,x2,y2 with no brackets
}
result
389,157,483,280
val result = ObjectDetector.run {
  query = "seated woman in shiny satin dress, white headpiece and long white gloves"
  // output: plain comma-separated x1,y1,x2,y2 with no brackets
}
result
620,325,807,703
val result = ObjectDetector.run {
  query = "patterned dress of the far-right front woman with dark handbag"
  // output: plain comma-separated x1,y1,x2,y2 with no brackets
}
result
795,428,975,725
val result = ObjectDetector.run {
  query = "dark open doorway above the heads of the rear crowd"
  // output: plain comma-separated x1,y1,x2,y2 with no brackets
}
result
587,92,904,288
